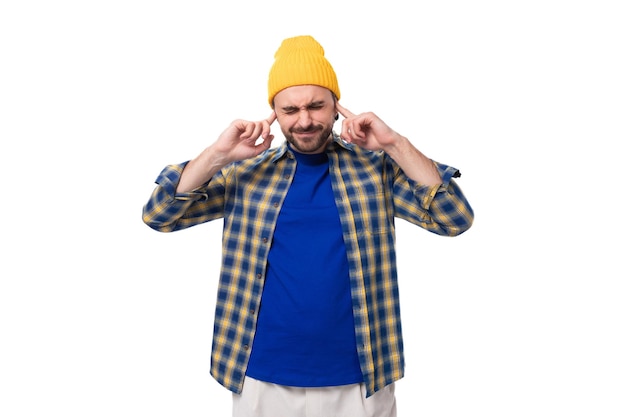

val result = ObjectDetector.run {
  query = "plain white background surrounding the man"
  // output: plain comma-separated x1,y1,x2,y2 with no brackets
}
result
0,0,626,417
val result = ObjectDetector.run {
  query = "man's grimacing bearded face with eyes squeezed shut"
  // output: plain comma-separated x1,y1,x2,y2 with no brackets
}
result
274,85,337,153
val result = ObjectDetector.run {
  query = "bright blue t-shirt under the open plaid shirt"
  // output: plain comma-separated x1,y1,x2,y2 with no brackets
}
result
246,146,363,387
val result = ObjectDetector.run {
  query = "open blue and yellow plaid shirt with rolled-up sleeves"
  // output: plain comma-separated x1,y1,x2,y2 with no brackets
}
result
143,136,473,396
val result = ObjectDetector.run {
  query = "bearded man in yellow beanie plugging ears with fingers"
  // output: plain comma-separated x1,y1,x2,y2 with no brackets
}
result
143,36,473,417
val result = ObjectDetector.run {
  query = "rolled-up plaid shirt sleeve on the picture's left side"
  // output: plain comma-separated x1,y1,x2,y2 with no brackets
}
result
142,162,224,232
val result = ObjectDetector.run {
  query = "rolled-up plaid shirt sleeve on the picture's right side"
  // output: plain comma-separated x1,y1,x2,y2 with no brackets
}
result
394,161,474,236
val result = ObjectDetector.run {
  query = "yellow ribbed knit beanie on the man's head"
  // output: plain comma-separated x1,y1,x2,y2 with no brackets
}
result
267,35,340,106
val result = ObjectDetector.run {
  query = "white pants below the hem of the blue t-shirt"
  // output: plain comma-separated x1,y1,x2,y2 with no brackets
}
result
233,377,396,417
